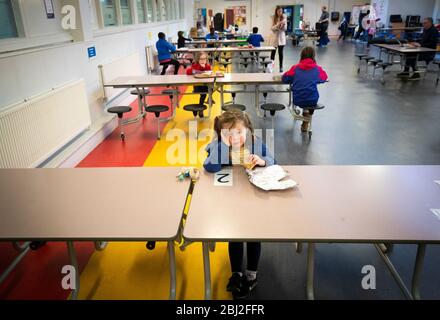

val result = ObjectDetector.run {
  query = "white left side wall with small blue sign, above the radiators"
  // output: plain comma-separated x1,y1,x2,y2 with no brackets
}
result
0,0,194,121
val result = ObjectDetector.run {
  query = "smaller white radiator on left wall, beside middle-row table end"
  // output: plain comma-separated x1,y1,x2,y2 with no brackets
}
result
98,51,146,103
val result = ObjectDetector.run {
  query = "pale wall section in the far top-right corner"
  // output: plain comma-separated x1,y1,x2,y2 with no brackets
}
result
387,0,436,24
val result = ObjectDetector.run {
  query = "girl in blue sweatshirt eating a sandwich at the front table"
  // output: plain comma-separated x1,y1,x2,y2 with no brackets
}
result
203,110,275,299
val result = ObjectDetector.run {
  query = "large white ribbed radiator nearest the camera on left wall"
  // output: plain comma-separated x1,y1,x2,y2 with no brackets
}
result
0,80,91,168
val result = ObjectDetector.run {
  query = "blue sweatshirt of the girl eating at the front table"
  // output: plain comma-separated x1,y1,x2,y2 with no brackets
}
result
203,137,276,173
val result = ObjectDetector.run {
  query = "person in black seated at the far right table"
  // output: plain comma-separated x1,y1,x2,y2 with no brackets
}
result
397,18,439,80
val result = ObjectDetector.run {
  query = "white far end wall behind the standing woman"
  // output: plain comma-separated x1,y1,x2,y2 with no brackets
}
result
196,0,369,36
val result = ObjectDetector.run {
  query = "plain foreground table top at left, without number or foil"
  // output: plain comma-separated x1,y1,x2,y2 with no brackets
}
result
0,167,189,241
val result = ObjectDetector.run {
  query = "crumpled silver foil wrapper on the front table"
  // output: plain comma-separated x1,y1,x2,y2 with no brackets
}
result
246,165,298,191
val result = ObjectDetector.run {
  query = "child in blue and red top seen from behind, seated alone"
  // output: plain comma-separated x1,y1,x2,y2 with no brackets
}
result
282,47,328,132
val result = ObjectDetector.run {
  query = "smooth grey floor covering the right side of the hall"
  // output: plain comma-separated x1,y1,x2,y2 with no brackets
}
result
227,41,440,299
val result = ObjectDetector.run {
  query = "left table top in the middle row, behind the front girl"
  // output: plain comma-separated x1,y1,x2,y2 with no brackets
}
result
104,74,214,88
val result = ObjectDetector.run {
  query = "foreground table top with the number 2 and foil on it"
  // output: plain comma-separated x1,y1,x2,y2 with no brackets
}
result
184,166,440,243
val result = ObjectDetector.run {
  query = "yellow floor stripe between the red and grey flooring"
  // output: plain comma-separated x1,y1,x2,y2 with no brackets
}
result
79,73,237,300
